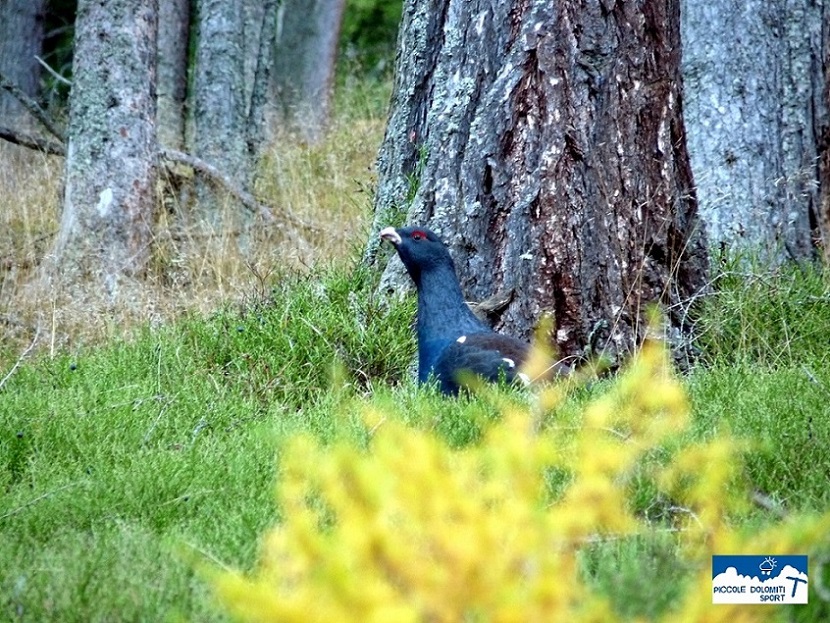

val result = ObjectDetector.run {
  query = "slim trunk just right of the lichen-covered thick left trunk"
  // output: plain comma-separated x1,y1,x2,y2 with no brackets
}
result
157,0,190,149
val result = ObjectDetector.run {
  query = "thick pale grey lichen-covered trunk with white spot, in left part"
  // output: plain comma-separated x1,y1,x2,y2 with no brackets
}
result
55,0,158,300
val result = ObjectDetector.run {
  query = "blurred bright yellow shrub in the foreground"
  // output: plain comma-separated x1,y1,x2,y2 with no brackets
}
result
213,341,830,623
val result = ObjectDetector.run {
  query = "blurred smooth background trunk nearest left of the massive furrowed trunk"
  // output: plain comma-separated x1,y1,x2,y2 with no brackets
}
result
274,0,345,142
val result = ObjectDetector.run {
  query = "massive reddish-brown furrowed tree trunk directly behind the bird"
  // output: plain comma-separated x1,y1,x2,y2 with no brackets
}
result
367,0,707,366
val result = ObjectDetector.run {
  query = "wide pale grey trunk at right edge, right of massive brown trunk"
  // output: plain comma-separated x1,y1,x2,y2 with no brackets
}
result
682,0,830,261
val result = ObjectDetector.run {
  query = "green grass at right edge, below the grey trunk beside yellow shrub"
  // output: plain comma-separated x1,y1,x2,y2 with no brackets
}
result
689,261,830,510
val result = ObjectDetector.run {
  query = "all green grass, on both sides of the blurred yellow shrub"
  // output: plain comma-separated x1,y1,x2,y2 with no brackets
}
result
0,258,830,621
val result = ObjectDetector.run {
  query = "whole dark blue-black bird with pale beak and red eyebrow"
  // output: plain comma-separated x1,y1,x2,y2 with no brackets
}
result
380,227,530,394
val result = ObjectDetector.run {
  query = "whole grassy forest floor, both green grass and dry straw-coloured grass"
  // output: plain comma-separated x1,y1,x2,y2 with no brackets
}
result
0,73,830,622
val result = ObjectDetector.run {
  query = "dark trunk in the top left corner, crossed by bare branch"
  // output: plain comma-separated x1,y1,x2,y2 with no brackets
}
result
0,0,46,129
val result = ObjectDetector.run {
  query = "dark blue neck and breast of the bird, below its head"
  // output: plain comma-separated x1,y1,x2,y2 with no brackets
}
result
417,264,488,381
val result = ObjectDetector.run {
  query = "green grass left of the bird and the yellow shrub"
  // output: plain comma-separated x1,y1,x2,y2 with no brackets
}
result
0,269,414,621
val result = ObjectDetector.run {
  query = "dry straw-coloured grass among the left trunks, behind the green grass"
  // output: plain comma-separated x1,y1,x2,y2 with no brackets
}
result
0,79,389,350
